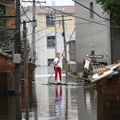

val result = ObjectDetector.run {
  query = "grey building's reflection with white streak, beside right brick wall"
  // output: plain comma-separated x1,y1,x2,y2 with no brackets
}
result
77,85,97,120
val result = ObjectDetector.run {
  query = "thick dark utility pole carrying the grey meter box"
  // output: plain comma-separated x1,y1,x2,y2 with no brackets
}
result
15,0,21,94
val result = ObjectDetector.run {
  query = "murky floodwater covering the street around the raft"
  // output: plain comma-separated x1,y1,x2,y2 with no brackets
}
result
0,67,97,120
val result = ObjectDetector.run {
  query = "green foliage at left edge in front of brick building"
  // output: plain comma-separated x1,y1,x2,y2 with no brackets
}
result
0,12,12,47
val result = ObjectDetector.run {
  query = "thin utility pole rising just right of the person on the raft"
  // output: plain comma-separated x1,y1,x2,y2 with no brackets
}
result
62,15,68,82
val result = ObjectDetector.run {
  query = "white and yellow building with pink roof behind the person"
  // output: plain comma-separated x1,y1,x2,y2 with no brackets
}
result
21,6,75,66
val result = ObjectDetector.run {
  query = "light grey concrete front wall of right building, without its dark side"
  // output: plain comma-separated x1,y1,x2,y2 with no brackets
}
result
75,0,111,71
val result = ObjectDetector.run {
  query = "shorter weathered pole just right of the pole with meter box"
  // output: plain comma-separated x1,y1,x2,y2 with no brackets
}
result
23,21,28,80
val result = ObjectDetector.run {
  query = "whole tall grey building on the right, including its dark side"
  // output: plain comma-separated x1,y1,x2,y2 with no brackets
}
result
75,0,120,71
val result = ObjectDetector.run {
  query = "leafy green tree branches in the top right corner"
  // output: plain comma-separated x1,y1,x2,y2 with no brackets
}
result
96,0,120,26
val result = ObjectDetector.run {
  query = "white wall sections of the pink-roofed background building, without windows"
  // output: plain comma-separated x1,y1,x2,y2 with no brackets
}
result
21,10,75,66
